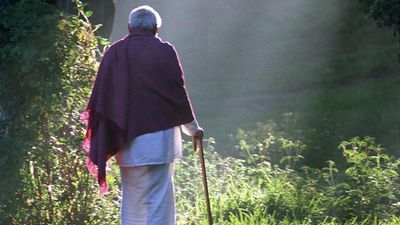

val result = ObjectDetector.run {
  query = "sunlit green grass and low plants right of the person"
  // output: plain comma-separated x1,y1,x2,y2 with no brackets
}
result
175,132,400,224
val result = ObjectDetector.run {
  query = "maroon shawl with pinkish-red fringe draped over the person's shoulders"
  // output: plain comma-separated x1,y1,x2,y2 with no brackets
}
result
81,32,194,196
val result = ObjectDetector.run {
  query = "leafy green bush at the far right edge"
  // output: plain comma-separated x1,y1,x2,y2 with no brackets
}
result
340,137,400,219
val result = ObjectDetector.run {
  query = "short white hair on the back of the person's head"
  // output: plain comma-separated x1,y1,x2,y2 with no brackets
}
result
129,5,162,30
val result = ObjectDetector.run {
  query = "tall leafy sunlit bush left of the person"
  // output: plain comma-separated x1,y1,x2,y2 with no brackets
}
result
0,0,120,224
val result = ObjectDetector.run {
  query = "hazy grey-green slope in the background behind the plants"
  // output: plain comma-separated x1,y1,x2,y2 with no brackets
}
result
112,0,400,165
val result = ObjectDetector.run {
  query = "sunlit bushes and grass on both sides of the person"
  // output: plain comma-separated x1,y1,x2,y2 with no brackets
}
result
0,0,400,225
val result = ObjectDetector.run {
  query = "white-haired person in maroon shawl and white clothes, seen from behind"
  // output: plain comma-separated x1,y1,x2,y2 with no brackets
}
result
82,6,203,225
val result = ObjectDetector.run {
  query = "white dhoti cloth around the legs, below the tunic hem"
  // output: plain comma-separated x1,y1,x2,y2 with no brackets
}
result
120,163,175,225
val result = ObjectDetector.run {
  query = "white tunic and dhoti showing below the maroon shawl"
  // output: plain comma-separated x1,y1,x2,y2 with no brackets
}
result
116,120,199,225
